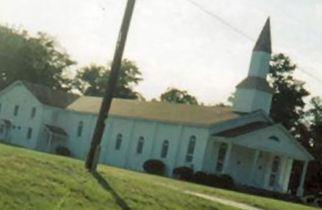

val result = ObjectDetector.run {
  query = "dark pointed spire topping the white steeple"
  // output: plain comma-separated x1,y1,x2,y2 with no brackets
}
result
253,17,272,53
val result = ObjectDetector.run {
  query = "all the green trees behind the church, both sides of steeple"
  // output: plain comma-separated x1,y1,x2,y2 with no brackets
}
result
0,26,322,195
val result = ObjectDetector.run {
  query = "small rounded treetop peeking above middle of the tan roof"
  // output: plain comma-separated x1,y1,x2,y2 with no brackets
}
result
160,88,198,105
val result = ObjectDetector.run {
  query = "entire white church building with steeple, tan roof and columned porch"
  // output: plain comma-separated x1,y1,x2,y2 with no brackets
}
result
0,20,313,195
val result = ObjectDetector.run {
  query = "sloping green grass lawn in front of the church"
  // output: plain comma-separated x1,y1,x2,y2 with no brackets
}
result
0,144,313,210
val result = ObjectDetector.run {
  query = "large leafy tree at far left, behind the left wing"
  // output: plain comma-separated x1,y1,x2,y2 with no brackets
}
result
0,25,75,90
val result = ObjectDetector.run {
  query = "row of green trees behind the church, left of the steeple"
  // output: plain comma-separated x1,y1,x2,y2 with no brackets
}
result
0,25,198,104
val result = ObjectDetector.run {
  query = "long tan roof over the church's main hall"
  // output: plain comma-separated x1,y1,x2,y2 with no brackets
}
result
67,96,240,126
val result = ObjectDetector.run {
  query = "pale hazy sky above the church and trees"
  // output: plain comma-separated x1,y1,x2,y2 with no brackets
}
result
0,0,322,104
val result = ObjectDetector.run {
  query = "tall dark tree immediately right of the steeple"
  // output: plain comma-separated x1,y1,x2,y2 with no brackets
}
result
269,53,309,142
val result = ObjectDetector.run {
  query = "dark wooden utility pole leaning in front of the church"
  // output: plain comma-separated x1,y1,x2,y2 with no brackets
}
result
85,0,136,173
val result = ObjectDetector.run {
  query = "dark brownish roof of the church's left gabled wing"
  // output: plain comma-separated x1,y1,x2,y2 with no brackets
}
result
21,81,79,108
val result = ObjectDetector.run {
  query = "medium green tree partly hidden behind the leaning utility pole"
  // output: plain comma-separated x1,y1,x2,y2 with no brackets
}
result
73,59,144,100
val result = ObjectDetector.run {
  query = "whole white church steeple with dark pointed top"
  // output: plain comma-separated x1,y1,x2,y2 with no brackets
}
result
233,18,272,114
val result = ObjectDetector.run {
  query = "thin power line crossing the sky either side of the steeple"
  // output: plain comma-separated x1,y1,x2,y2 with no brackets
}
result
186,0,322,86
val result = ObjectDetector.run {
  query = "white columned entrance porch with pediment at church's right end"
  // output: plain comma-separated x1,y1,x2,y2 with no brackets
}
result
204,122,313,196
